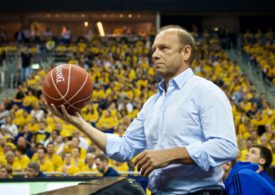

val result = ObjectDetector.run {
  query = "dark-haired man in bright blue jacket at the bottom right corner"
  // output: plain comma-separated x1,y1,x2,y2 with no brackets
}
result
223,145,275,195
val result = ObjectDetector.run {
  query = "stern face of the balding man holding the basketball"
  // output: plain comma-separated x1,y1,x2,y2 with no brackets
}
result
152,30,183,79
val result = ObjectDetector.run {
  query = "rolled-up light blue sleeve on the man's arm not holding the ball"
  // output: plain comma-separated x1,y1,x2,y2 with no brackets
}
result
186,85,238,171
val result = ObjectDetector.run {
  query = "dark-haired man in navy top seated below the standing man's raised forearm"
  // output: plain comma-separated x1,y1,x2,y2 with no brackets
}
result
95,154,120,177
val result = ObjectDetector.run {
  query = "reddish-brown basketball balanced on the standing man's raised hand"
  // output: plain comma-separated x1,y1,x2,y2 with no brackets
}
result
42,64,93,114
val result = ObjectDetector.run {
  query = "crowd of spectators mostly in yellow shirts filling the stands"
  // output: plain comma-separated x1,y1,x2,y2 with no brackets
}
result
0,26,275,180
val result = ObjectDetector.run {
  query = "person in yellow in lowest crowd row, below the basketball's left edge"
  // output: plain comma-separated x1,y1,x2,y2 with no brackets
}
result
37,147,54,172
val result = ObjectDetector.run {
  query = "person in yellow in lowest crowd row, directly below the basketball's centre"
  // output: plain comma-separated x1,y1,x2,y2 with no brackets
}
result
58,152,79,176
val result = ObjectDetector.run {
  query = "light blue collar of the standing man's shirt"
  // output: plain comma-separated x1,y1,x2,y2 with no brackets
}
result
158,68,194,93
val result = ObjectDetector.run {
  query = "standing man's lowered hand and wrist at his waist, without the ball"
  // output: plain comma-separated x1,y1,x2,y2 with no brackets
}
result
134,150,171,176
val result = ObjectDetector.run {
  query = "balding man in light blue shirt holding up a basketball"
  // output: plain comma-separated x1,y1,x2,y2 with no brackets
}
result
48,26,238,194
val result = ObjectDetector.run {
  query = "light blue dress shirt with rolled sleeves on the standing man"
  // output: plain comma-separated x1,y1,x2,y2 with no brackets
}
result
106,68,238,194
